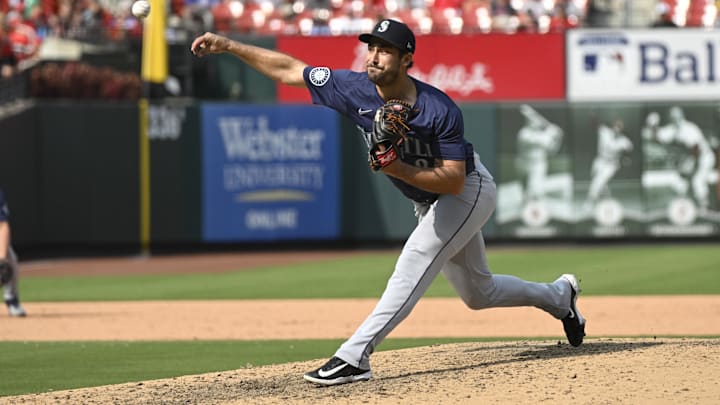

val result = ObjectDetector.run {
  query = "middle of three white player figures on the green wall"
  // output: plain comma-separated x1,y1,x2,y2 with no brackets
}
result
587,120,633,206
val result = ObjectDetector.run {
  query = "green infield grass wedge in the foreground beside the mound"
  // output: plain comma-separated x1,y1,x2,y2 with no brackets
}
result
0,338,478,394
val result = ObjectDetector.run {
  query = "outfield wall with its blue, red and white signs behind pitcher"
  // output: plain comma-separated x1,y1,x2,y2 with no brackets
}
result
0,29,720,247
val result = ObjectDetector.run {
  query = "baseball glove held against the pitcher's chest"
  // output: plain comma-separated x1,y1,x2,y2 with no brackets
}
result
369,99,413,170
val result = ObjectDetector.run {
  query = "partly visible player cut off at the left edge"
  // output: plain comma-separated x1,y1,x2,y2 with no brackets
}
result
0,188,26,317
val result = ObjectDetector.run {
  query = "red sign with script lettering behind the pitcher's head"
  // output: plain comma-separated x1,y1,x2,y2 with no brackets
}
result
277,34,565,102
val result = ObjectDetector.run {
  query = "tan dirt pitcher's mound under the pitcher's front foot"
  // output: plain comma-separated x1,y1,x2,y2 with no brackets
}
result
7,339,720,405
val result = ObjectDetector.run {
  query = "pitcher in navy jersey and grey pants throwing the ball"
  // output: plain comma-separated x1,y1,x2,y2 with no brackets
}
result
190,20,585,385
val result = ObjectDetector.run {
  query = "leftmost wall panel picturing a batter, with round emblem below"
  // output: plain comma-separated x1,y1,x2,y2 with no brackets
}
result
495,104,576,238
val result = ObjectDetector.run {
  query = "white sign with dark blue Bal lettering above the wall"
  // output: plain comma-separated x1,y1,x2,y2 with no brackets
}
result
567,28,720,101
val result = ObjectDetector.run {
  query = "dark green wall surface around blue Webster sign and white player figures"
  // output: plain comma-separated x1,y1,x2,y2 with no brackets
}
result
0,101,720,254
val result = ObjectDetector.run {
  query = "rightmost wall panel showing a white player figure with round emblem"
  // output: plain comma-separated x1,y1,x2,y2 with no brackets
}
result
641,103,720,237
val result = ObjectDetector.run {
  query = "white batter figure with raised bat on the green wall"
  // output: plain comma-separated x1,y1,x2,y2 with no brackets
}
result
517,104,563,202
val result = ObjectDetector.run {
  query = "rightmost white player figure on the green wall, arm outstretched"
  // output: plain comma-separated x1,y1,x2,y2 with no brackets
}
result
642,106,718,211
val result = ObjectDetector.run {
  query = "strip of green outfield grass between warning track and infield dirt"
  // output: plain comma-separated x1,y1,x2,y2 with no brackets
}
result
21,245,720,301
